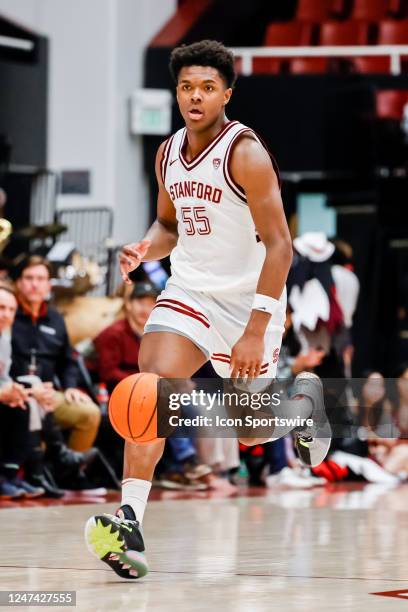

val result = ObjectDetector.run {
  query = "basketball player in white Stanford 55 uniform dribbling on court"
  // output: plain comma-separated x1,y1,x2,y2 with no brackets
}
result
86,40,330,578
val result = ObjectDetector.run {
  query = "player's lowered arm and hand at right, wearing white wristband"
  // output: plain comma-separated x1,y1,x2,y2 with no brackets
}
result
231,136,293,376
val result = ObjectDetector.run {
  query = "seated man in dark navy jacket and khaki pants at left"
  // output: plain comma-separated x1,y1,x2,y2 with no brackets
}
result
11,255,101,452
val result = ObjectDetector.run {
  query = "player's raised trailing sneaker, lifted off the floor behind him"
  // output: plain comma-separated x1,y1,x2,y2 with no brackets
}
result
292,372,332,467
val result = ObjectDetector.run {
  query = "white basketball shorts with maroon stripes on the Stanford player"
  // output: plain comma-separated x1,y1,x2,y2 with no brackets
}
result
144,279,286,378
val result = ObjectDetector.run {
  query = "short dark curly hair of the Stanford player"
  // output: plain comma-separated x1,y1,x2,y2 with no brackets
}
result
169,40,237,87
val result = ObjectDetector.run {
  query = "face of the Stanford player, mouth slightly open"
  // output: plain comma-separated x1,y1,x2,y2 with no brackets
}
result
177,66,232,132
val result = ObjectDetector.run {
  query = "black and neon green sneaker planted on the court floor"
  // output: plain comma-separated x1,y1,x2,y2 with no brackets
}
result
85,505,149,580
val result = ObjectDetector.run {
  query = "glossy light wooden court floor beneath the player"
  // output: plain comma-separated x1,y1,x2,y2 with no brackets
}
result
0,485,408,612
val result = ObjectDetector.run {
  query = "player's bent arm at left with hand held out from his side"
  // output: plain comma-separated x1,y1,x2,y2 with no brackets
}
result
119,143,178,283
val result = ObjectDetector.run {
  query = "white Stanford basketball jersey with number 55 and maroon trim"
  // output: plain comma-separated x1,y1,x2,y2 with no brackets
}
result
161,121,274,293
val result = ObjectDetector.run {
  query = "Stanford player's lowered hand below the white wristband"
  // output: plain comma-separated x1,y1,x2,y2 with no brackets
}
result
230,332,265,379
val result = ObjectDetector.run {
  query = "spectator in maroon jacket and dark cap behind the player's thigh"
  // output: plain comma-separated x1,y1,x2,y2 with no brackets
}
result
93,282,159,393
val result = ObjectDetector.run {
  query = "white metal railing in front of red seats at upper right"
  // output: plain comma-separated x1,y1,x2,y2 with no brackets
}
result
231,45,408,76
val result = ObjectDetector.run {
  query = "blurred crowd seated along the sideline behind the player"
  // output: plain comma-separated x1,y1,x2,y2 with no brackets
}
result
0,233,408,499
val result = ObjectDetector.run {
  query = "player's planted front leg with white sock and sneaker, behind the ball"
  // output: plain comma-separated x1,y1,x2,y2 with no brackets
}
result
85,331,207,579
